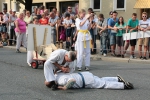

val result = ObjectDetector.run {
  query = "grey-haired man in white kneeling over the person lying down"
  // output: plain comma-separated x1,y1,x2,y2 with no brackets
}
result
44,49,76,89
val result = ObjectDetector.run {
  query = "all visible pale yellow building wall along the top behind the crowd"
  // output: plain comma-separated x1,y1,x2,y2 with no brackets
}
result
0,0,141,21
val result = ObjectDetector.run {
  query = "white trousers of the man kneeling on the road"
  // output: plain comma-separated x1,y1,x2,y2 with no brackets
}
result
44,61,56,82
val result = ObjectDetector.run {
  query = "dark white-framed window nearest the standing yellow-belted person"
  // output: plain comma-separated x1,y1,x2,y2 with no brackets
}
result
91,0,102,11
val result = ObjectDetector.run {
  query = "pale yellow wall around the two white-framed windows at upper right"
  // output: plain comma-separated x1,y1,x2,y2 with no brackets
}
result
79,0,140,21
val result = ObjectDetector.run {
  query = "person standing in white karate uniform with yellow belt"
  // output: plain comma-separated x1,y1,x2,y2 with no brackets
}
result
76,9,92,71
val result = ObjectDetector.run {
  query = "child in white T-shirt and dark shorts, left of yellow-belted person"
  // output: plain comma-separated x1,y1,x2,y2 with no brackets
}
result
64,13,72,50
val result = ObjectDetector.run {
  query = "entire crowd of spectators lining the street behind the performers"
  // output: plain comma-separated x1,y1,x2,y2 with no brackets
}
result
0,6,150,60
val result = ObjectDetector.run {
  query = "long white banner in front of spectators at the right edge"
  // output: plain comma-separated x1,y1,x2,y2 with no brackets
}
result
123,31,150,40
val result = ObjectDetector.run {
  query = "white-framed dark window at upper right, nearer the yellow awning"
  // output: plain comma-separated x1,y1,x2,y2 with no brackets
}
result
114,0,126,10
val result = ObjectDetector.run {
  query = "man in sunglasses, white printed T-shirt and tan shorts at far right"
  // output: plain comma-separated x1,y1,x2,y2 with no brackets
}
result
138,12,150,60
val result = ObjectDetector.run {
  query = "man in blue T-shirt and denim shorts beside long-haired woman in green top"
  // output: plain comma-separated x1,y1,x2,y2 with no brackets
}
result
108,11,118,56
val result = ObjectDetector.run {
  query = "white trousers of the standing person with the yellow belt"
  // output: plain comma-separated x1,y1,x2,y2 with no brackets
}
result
76,41,91,68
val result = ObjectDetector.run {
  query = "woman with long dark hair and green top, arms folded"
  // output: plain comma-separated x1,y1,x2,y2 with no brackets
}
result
114,16,126,58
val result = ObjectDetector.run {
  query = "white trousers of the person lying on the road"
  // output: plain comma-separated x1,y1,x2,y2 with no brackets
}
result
92,76,124,89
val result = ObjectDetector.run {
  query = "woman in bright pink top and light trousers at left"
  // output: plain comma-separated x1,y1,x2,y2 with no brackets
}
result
15,13,27,53
